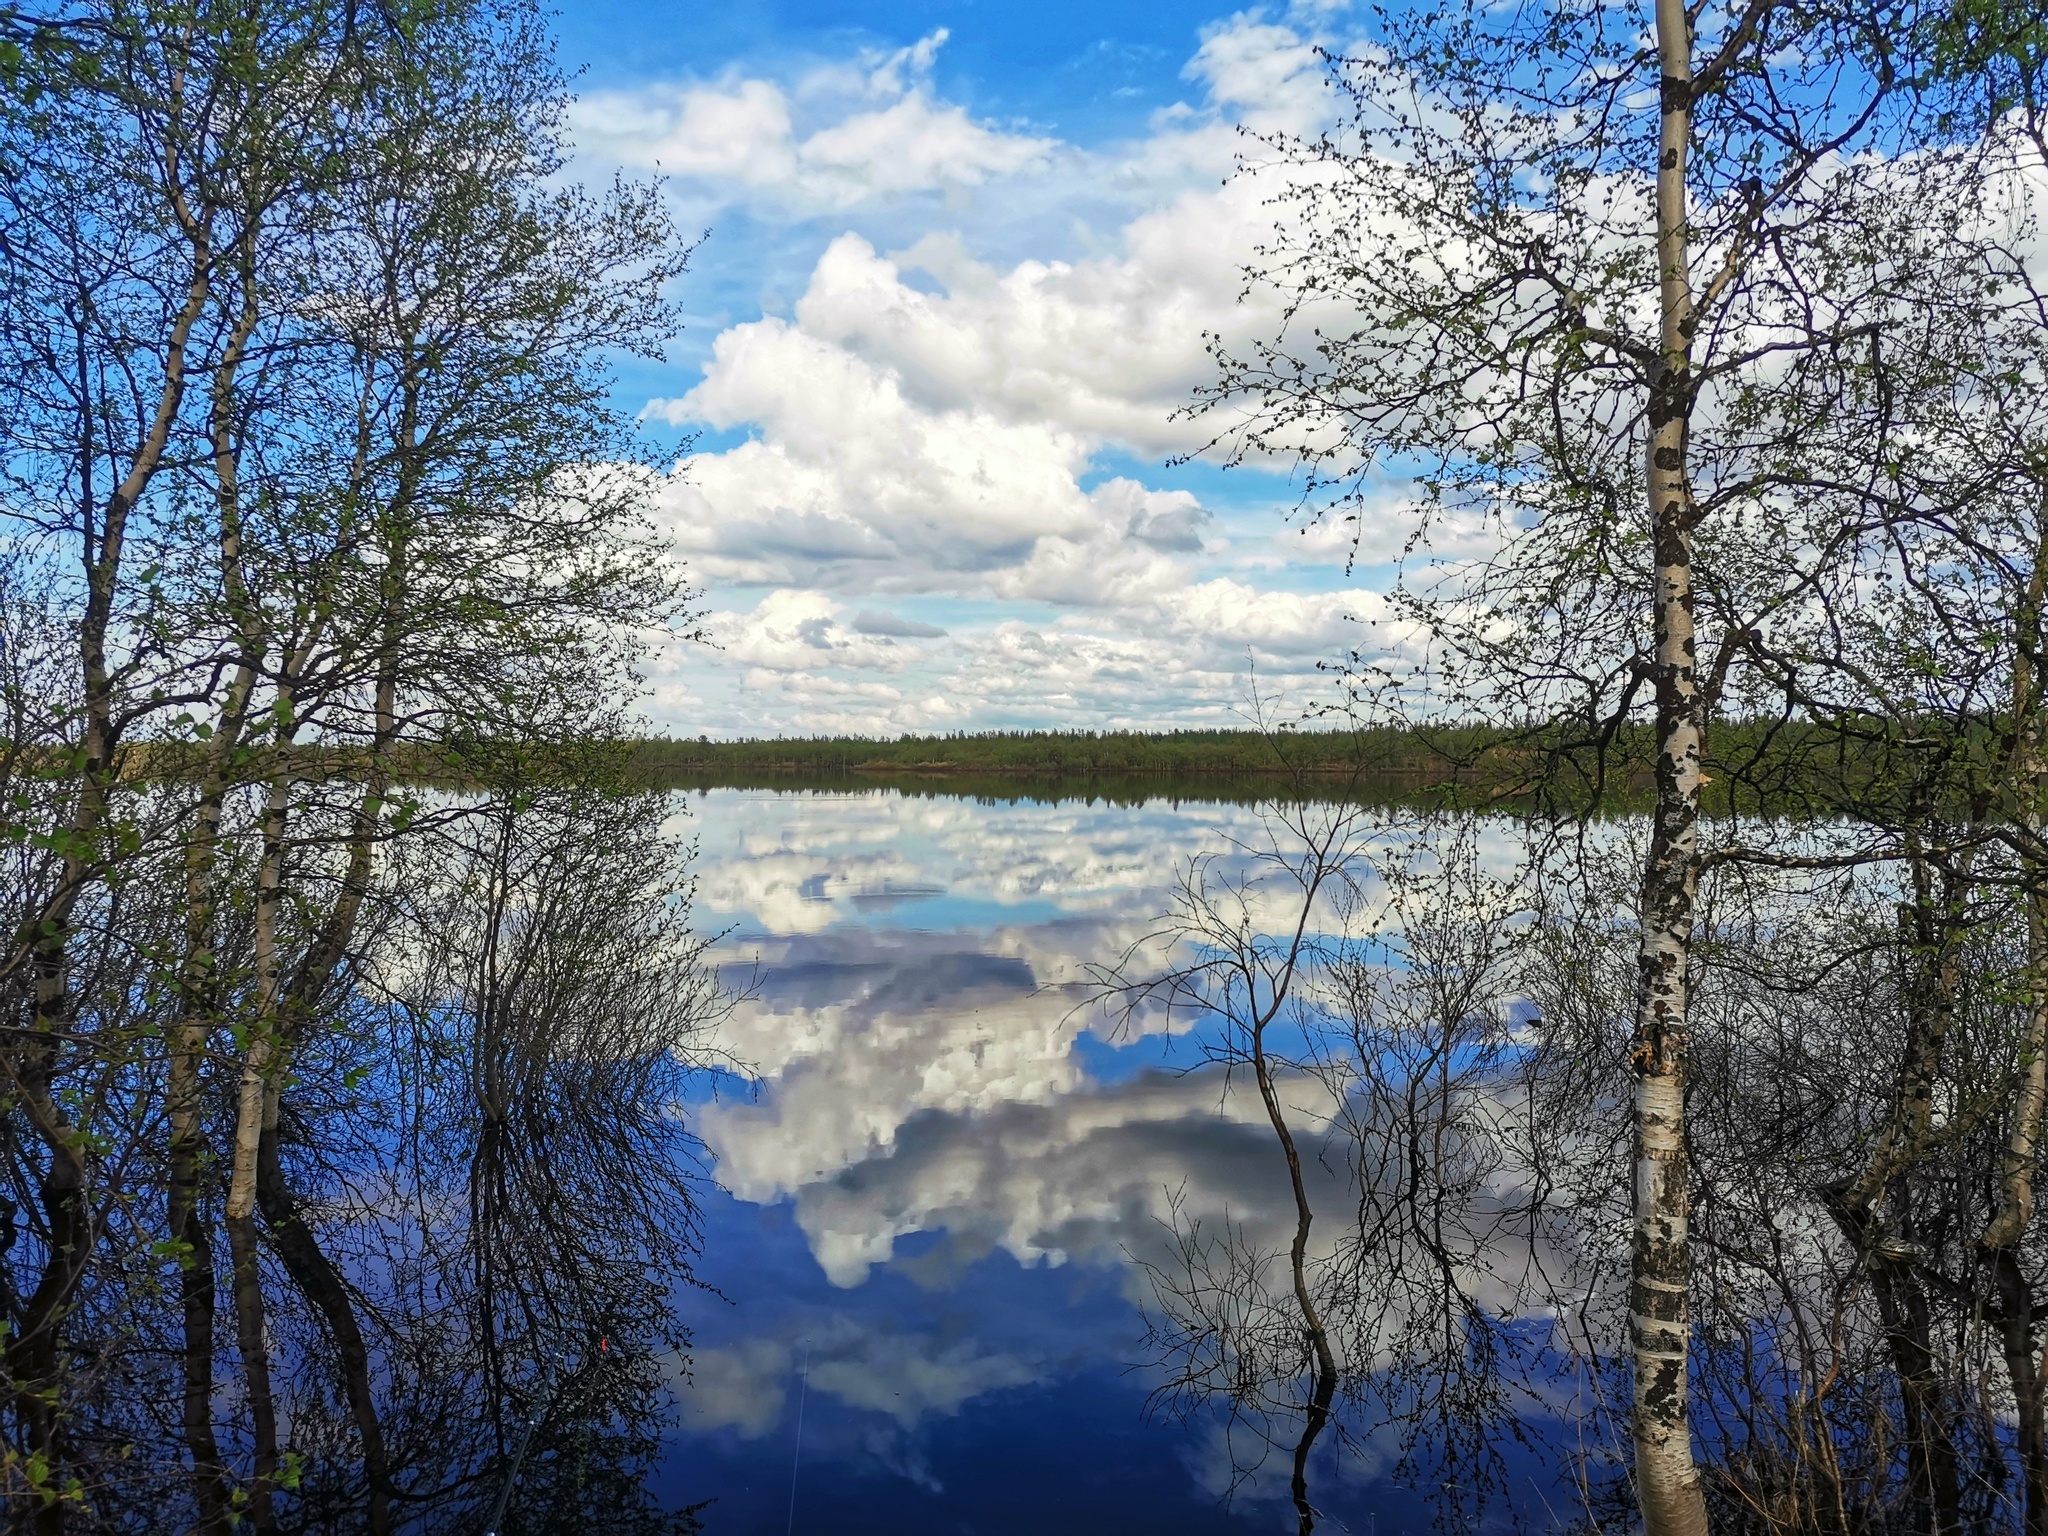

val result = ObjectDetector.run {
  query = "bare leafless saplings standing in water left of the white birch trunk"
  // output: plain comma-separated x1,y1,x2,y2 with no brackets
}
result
1100,803,1542,1534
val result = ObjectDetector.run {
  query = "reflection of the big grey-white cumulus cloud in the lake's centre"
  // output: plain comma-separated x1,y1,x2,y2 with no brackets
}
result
700,921,1329,1288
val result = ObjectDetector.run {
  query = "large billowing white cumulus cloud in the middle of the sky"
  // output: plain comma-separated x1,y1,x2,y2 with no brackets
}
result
647,195,1302,604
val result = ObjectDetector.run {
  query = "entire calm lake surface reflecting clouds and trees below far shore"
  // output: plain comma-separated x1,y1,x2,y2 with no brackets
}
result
39,764,2007,1532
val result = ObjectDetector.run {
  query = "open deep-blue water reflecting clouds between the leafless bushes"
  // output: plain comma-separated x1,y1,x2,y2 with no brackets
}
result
659,791,1548,1534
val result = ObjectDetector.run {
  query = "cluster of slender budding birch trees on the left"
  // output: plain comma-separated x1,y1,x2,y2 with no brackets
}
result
0,2,712,1530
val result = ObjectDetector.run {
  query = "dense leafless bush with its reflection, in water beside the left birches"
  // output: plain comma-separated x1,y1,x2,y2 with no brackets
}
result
280,786,723,1534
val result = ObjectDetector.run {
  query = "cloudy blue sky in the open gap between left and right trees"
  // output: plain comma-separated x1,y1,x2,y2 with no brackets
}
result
559,0,1441,737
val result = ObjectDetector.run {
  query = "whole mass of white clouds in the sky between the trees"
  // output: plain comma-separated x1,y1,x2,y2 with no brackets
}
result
598,6,1417,733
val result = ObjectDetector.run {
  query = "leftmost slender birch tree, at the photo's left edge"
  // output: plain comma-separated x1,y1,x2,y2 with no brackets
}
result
0,6,374,1526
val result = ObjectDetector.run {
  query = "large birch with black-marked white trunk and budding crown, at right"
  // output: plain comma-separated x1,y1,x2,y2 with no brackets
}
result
1206,0,1968,1536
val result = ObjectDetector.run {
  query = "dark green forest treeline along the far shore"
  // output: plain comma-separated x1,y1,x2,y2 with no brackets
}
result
83,717,1999,819
